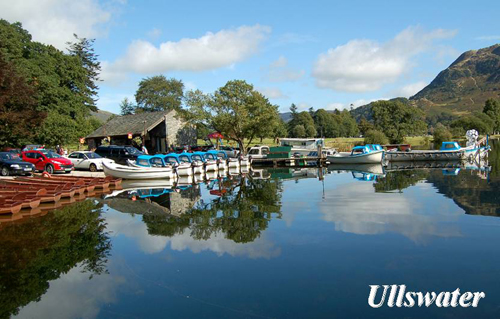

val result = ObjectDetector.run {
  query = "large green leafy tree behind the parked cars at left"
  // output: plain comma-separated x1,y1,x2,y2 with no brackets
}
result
0,19,100,145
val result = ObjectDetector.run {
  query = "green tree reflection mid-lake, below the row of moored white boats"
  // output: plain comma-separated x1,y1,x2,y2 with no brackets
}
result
143,178,282,243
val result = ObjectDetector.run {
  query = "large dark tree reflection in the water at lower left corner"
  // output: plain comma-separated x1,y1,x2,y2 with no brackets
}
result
0,200,111,318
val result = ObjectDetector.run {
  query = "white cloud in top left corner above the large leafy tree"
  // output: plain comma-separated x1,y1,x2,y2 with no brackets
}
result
0,0,111,50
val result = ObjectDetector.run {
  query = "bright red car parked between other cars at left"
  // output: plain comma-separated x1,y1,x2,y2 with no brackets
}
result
23,150,74,174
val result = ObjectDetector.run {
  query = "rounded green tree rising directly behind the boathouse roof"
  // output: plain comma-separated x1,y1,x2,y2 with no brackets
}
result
135,75,184,112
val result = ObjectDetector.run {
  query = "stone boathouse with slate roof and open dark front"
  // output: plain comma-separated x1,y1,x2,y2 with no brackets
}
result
85,110,196,154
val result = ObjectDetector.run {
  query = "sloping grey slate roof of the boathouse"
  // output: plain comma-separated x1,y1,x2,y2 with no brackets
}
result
87,111,173,138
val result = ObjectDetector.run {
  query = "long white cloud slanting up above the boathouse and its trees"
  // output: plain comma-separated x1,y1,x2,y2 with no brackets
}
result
102,24,271,81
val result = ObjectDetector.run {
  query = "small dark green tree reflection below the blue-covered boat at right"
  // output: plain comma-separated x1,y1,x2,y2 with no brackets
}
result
373,169,429,193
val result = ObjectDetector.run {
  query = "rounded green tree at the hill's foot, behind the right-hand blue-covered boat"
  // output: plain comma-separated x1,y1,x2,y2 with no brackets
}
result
372,101,426,143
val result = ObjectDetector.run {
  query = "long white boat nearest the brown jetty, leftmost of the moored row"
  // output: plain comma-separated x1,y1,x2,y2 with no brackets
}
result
103,163,174,179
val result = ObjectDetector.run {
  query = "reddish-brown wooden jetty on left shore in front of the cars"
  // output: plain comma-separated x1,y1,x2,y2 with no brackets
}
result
0,176,121,223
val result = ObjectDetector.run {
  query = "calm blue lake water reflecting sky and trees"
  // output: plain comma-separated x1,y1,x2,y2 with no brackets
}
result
0,143,500,318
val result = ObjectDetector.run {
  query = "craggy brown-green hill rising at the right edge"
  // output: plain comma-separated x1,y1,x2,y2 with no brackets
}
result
351,44,500,121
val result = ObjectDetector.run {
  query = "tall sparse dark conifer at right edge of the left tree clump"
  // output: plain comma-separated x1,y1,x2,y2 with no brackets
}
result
67,34,101,111
